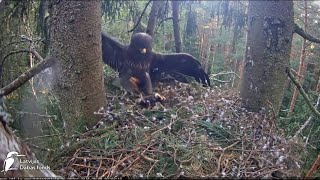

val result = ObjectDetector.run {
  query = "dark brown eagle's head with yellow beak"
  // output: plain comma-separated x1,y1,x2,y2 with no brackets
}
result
129,33,152,56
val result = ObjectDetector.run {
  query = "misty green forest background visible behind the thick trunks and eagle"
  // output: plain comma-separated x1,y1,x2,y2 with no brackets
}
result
0,0,320,178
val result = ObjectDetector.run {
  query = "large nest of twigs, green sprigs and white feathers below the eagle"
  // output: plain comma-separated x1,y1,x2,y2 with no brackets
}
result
48,74,303,178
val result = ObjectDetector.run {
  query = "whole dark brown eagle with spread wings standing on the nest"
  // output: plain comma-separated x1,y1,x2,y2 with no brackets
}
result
102,32,210,100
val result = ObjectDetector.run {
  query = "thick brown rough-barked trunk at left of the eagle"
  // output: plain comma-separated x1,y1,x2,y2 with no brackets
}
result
49,0,106,135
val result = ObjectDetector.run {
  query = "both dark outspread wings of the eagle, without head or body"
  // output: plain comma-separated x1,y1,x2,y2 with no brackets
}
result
102,33,210,86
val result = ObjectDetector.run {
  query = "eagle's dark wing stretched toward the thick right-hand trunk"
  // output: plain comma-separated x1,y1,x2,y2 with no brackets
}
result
150,53,210,86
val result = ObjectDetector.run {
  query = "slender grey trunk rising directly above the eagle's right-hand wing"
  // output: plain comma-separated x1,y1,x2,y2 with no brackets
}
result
172,1,182,53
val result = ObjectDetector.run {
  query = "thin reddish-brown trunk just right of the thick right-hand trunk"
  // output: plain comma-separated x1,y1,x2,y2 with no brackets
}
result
288,0,308,115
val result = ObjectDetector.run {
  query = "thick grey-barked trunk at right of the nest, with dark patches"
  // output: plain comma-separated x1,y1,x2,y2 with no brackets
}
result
240,1,294,113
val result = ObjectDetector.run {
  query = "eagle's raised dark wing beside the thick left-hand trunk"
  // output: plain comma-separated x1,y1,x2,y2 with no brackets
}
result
101,33,128,72
